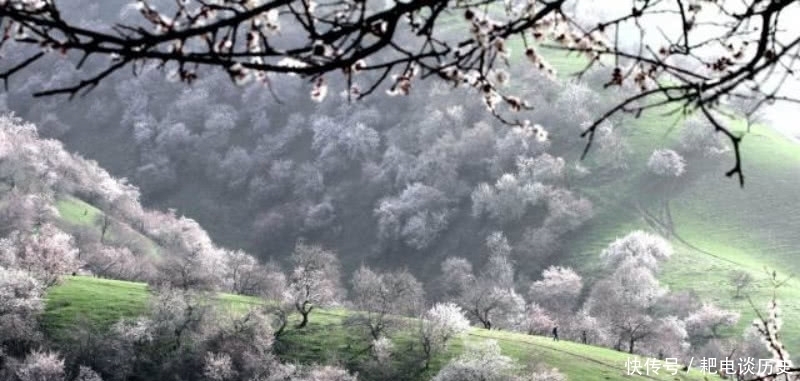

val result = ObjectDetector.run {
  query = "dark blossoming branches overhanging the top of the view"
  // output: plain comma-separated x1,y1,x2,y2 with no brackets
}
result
0,0,800,186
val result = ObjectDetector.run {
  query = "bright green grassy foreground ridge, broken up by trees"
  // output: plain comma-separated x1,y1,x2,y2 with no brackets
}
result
47,277,724,381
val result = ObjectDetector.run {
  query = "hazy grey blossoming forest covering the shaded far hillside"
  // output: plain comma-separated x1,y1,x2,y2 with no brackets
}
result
0,2,625,279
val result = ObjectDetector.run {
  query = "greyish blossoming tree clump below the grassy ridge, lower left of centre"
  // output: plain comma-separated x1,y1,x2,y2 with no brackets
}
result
100,289,300,381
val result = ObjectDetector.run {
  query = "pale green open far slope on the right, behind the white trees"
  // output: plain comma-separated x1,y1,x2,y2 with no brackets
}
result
524,49,800,352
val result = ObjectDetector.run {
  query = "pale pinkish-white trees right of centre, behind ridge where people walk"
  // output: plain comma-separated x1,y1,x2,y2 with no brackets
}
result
439,231,760,357
